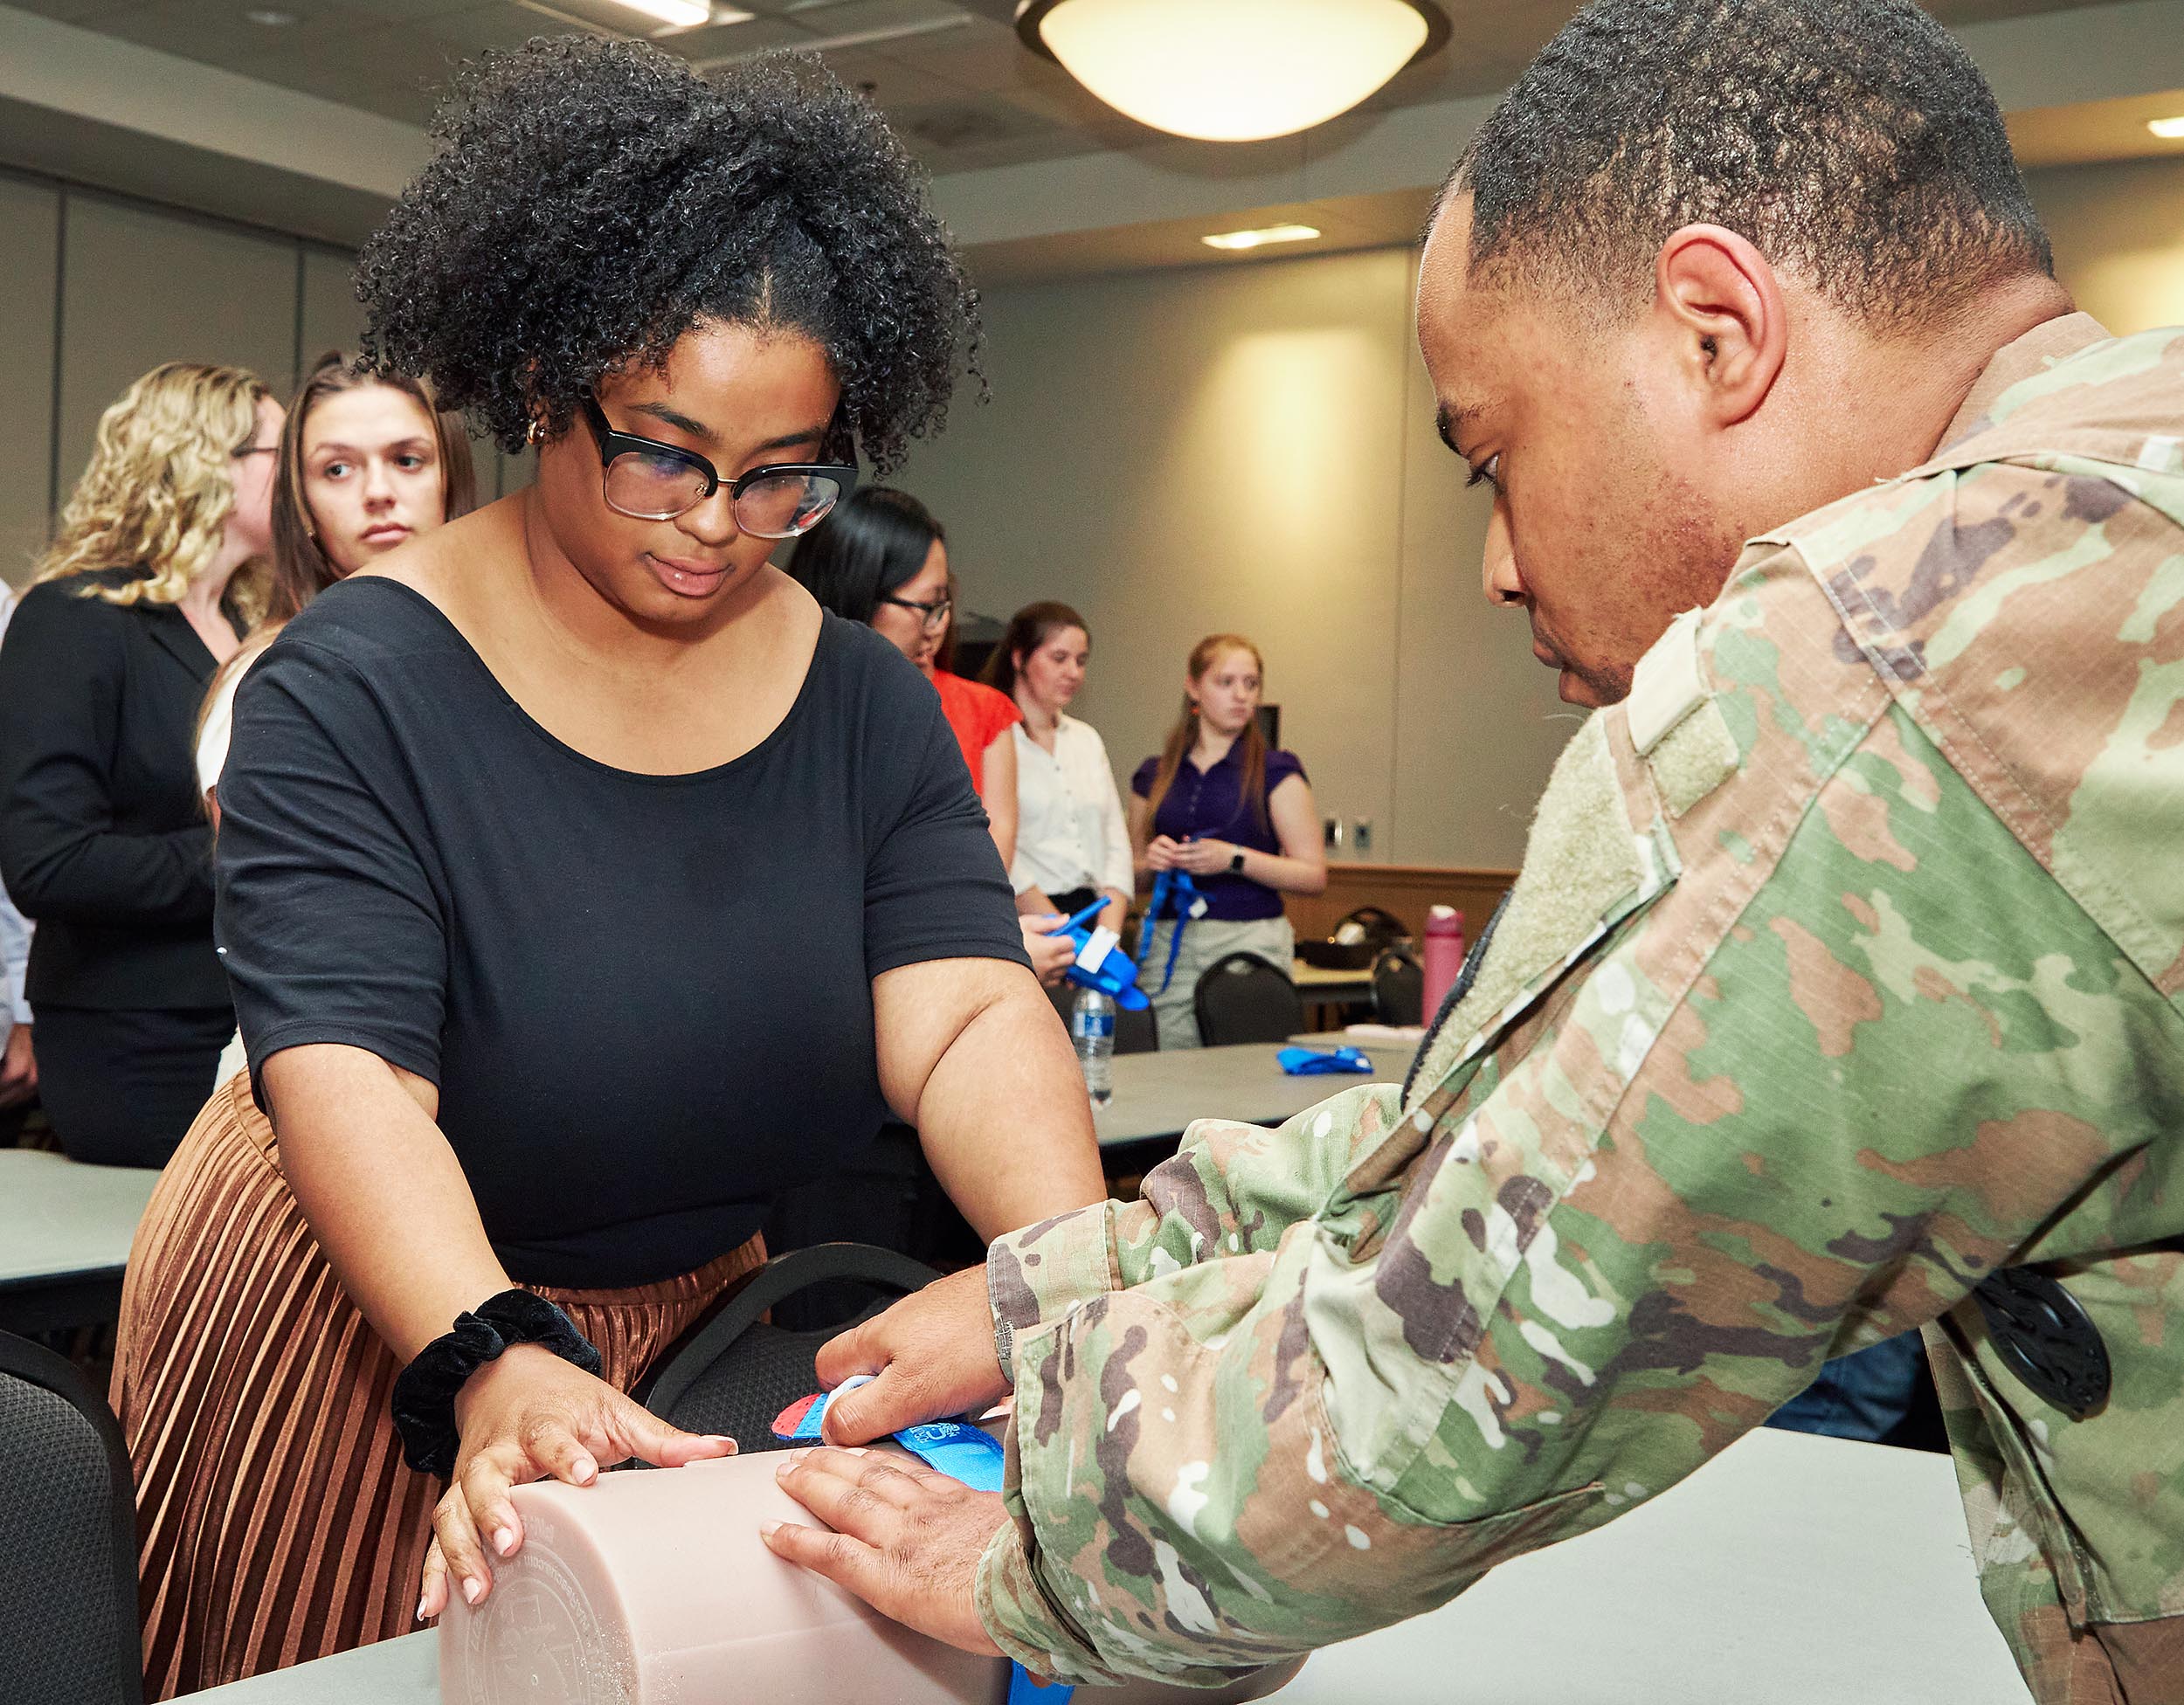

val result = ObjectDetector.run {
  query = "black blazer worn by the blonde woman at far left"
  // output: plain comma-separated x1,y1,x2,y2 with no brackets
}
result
0,569,230,1009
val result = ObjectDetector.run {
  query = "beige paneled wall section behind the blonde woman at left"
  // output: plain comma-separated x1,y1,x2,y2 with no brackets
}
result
0,172,529,585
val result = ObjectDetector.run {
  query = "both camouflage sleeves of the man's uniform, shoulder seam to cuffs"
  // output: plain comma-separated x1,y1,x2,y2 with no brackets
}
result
978,521,2178,1681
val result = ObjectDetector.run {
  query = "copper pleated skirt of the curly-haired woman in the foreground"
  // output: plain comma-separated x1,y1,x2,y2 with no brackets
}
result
114,1074,764,1699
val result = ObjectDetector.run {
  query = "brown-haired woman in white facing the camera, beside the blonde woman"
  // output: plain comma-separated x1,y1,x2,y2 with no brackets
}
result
197,351,479,827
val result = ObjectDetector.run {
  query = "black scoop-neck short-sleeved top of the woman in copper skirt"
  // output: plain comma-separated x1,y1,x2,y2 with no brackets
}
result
217,578,1025,1286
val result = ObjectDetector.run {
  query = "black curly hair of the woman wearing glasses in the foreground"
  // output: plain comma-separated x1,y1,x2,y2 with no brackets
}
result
356,37,978,473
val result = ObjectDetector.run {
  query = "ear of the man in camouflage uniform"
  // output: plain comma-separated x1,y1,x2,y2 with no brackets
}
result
1654,224,1789,425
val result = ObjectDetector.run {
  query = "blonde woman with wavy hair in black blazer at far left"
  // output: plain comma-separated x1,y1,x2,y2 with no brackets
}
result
0,362,282,1166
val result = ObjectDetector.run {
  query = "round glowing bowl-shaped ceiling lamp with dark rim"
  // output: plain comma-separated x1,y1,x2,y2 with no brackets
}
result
1016,0,1448,142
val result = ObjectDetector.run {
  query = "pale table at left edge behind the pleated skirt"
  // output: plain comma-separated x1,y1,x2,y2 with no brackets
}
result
0,1149,160,1332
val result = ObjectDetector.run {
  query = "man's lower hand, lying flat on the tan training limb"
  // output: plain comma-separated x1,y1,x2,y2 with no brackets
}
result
760,1440,1009,1657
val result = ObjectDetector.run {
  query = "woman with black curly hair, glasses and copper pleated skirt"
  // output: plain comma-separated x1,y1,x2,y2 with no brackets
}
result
114,39,1105,1695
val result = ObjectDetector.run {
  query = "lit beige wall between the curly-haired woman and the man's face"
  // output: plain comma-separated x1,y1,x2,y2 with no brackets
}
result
900,249,1571,865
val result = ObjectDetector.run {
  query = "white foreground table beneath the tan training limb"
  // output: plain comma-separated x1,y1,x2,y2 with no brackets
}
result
195,1430,2029,1705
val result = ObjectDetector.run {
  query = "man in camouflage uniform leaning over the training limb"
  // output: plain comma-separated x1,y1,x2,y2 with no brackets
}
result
771,0,2184,1705
